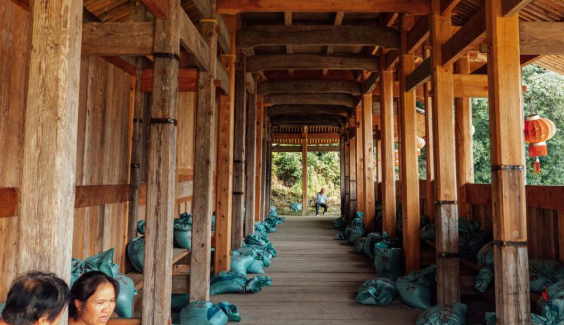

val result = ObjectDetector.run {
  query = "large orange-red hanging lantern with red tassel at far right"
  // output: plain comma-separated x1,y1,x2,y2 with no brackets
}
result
525,114,556,174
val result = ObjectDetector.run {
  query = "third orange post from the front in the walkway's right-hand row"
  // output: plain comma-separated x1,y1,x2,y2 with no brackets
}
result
398,15,425,273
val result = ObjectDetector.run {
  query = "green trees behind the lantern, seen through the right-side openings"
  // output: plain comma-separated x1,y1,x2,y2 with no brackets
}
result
472,64,564,185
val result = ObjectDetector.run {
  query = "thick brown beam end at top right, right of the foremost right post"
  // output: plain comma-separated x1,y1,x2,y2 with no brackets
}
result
519,21,564,55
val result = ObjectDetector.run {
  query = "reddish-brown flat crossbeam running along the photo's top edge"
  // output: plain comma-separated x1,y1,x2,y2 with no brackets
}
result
217,0,429,15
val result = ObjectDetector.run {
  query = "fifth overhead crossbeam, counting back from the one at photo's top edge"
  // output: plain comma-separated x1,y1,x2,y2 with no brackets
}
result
264,93,354,108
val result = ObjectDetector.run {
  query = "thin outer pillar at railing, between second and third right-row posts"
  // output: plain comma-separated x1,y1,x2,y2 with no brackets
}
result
423,43,435,222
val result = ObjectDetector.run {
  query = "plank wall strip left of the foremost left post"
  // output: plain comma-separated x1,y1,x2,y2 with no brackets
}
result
0,1,30,301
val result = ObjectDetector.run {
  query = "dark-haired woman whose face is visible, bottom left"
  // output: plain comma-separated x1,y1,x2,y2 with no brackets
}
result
69,271,119,325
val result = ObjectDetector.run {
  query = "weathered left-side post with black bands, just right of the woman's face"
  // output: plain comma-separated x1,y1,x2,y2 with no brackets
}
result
142,1,182,318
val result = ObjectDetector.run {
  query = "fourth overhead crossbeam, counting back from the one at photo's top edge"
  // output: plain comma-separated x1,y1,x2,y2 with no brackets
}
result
258,80,362,96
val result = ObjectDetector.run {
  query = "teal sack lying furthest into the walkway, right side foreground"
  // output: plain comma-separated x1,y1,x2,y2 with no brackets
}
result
356,278,398,306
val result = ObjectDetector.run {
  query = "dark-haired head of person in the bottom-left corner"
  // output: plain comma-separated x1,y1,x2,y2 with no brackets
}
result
0,271,70,325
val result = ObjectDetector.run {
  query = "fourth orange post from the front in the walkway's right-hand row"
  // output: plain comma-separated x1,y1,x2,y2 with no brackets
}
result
380,57,396,236
